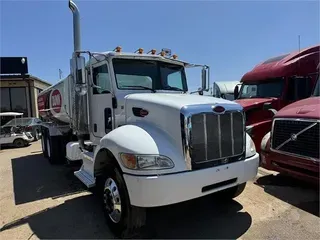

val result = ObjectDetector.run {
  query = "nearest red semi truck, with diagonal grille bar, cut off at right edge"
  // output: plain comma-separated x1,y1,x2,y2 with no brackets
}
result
260,67,320,184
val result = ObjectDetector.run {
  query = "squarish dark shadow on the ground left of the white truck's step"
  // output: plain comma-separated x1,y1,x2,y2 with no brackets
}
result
11,153,85,205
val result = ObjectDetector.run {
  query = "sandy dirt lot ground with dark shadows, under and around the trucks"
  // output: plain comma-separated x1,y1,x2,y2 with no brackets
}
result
0,141,320,239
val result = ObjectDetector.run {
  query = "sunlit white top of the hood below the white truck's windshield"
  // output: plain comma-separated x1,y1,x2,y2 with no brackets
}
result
125,93,238,110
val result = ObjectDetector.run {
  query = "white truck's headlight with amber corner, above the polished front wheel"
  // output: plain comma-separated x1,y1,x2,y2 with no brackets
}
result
120,153,174,170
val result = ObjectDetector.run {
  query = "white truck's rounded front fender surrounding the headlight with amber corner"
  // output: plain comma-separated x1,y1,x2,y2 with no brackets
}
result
95,122,188,175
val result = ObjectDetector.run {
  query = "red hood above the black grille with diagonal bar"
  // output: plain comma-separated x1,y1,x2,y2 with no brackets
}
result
275,97,320,119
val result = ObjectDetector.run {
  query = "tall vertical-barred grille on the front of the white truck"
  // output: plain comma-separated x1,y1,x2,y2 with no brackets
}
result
189,112,245,165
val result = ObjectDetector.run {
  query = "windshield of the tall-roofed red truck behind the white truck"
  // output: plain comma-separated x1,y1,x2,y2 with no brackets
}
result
238,78,284,99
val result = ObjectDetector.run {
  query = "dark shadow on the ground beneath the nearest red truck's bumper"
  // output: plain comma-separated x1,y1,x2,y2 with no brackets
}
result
256,174,320,217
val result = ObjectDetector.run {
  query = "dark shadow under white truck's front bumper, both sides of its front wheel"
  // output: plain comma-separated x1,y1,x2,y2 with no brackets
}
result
0,195,252,239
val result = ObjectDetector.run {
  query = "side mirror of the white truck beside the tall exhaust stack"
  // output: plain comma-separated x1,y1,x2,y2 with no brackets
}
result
70,54,87,95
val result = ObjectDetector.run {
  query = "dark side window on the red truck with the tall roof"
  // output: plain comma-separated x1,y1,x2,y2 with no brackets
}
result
287,78,312,101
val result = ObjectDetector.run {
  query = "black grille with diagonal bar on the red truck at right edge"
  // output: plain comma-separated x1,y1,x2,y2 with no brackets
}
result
271,119,320,159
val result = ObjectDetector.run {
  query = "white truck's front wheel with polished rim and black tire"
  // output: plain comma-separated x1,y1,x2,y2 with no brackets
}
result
101,167,146,238
